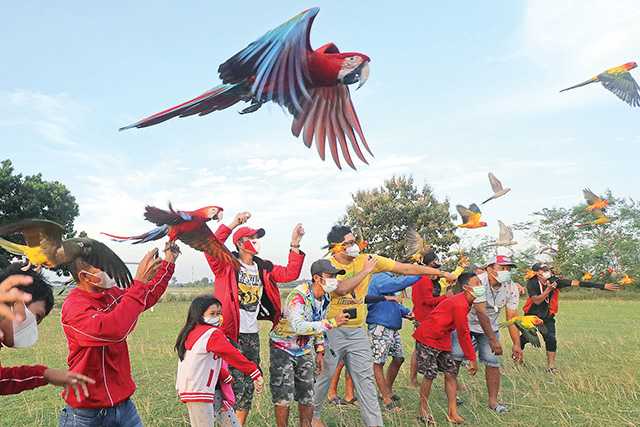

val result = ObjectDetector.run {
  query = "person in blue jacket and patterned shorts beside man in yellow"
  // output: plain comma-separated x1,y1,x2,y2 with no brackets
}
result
365,273,421,412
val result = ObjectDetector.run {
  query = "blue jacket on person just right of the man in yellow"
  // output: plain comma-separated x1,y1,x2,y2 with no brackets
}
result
367,273,421,330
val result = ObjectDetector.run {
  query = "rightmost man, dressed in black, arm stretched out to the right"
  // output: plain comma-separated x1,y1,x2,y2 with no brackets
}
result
520,262,620,374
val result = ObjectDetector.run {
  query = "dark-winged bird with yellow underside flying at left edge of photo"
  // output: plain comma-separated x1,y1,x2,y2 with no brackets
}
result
0,219,132,288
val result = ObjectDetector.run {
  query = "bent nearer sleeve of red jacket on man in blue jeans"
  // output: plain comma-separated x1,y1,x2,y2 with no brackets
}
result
61,280,152,347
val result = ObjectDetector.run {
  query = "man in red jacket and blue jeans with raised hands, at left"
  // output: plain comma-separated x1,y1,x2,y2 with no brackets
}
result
59,243,180,427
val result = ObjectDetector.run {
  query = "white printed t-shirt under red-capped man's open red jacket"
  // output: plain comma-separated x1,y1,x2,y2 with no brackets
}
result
238,261,262,334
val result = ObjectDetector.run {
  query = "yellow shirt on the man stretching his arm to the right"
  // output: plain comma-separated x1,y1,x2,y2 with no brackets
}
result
327,254,396,328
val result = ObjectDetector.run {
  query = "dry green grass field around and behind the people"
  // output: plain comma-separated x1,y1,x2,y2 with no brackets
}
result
0,291,640,426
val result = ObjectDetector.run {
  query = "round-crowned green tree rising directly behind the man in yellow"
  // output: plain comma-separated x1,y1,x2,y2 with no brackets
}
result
340,176,459,260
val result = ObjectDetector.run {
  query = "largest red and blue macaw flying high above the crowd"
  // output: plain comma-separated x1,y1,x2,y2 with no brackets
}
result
120,8,373,169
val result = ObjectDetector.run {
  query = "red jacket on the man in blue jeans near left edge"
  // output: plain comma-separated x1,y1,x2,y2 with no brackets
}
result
61,261,175,408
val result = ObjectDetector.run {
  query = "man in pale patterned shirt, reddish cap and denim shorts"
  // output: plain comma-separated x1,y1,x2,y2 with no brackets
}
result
452,255,522,414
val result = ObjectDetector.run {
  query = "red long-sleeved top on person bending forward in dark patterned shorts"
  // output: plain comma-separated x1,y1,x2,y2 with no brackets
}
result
413,292,476,361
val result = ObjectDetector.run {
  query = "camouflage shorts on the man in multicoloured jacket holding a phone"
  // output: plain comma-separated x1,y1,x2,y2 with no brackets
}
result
269,345,315,406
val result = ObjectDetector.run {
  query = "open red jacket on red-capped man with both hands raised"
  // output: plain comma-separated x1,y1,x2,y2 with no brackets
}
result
205,224,304,341
